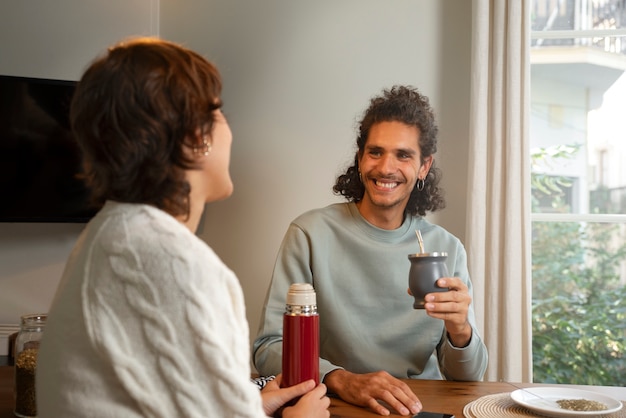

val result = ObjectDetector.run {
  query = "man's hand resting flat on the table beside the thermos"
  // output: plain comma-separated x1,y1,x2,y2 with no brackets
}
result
324,369,422,415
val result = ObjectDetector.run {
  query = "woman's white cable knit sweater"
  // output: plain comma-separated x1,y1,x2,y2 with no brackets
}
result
36,202,265,418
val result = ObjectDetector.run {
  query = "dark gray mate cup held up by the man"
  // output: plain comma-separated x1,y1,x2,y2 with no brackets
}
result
409,253,448,309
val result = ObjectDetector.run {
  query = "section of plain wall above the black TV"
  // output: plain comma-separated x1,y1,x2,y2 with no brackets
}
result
0,0,159,80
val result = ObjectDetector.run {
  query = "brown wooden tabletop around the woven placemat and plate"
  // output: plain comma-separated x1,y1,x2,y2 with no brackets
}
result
0,365,626,418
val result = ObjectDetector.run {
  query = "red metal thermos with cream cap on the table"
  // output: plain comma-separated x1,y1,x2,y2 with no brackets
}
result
281,283,320,387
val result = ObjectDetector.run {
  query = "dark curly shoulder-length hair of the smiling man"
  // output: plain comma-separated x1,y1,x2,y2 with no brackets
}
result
333,86,445,216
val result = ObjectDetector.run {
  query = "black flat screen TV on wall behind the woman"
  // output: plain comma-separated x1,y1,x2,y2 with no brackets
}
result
0,75,99,223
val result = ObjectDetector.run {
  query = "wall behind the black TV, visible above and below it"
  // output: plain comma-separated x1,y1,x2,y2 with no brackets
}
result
0,0,158,330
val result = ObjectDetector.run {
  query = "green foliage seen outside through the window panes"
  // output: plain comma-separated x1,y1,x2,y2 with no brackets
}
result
532,146,626,386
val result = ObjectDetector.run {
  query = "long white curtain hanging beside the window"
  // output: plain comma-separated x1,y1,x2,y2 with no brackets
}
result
466,0,532,382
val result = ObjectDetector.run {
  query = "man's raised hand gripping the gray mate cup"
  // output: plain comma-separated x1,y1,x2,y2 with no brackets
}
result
424,277,472,347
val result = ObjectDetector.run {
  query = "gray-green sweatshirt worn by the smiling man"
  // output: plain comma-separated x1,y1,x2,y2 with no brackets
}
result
253,203,487,381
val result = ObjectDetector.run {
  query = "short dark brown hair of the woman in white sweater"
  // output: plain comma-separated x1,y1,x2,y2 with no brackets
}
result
70,38,222,216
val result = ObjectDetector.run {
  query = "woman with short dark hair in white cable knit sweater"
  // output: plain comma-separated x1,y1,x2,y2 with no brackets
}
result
36,38,330,418
